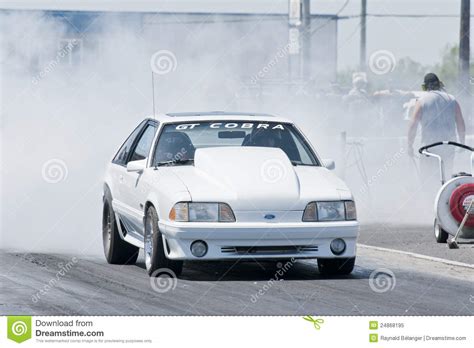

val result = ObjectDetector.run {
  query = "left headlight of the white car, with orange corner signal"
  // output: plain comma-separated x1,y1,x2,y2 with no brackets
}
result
169,202,235,222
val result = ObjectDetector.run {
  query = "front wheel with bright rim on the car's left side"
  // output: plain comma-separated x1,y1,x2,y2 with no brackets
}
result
144,206,183,276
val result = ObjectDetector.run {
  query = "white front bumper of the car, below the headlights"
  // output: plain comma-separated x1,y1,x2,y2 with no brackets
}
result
159,221,359,260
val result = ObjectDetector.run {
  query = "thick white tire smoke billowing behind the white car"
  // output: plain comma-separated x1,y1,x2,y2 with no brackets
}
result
0,12,466,255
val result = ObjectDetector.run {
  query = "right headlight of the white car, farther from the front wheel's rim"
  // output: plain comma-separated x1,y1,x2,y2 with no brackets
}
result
303,201,357,222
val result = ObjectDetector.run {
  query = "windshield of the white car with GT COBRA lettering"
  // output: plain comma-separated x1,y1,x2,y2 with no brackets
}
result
153,121,319,166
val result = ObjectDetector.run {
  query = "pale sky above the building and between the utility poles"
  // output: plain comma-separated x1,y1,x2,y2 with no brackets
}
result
0,0,468,69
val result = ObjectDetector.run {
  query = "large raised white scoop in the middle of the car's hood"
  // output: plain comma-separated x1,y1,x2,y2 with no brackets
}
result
194,146,300,210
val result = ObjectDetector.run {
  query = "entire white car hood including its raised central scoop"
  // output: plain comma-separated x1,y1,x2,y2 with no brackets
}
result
168,147,352,211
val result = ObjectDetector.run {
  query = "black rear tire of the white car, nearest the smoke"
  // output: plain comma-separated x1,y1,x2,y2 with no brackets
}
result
102,197,139,265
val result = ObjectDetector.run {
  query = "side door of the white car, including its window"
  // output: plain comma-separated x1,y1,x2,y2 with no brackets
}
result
120,121,157,238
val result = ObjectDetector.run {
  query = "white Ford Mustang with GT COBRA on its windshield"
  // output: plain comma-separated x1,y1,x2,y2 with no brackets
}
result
103,112,358,276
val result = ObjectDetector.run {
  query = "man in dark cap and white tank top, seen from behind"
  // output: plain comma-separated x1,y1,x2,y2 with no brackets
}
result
408,73,466,179
